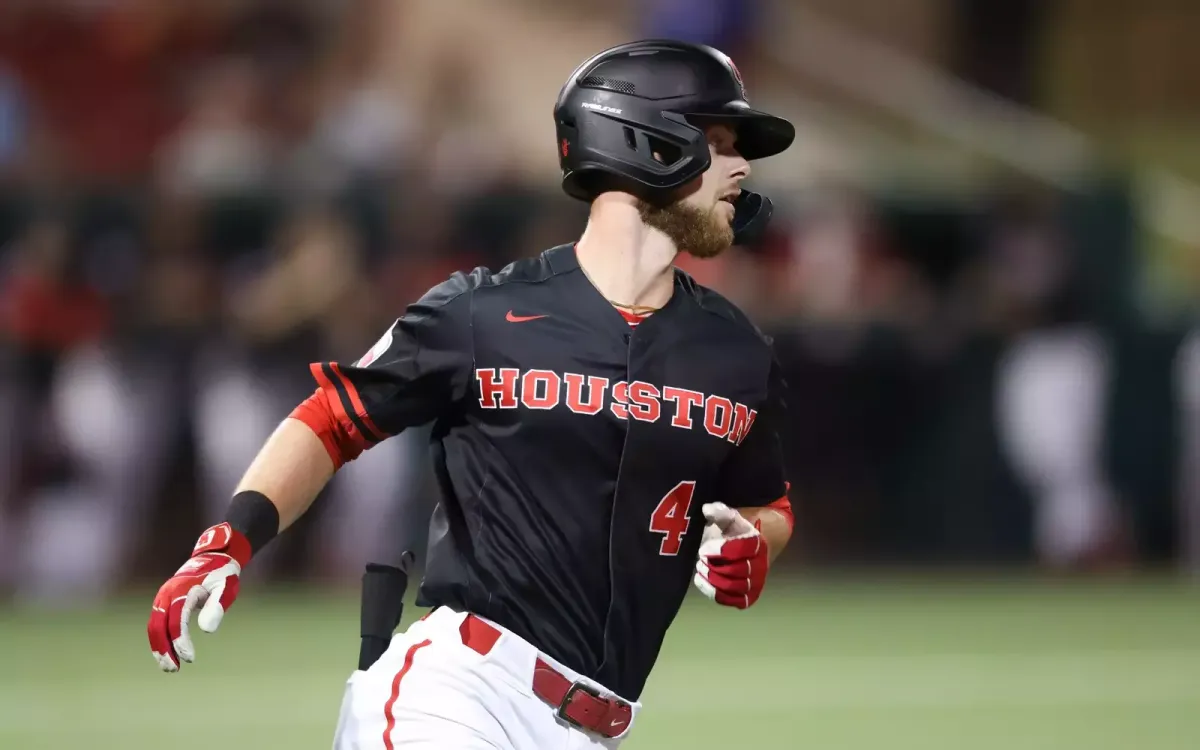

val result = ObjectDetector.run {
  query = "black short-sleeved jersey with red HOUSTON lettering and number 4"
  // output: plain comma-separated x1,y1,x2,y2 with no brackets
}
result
313,245,786,700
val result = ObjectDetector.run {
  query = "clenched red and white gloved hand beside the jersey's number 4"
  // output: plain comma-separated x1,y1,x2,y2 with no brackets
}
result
692,503,770,610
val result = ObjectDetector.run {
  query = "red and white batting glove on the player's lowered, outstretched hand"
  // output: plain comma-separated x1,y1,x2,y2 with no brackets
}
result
146,523,251,672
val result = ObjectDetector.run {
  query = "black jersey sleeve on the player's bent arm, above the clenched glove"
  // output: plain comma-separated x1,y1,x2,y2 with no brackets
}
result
718,358,788,508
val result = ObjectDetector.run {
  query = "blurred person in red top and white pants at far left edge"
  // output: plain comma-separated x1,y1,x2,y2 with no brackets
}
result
0,216,140,596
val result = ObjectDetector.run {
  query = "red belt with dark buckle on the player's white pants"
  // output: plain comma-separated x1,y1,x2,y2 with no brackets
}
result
458,614,634,738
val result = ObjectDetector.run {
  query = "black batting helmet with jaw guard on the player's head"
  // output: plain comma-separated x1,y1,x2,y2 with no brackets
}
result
554,40,796,245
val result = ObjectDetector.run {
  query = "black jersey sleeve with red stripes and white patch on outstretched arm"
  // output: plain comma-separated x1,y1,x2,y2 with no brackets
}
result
302,274,476,451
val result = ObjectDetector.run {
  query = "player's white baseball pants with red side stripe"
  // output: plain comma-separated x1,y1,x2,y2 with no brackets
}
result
334,607,641,750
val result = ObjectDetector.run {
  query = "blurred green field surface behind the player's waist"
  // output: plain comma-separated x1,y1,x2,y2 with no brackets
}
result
0,578,1200,750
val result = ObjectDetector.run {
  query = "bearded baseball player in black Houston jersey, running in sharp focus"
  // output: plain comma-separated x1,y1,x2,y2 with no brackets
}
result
149,41,794,750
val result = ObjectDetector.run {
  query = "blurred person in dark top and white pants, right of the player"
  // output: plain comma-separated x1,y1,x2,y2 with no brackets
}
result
986,193,1122,568
